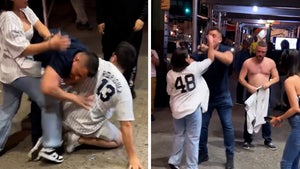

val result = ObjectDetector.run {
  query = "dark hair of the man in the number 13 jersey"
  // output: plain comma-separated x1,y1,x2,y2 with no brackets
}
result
114,41,137,71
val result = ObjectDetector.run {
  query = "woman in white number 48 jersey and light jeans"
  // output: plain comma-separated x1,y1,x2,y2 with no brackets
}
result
167,48,214,169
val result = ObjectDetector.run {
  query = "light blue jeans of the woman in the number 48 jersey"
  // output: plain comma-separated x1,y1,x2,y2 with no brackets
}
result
169,108,202,169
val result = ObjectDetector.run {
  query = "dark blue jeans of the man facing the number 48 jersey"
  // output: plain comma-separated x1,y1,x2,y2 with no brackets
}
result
199,93,234,158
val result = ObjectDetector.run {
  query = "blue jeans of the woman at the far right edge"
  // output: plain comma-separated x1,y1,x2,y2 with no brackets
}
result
280,113,300,169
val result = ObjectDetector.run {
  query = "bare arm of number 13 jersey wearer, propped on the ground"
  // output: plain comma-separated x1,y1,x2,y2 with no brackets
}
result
120,121,143,169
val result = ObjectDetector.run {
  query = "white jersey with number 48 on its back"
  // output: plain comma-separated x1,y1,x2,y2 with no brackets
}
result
167,59,212,119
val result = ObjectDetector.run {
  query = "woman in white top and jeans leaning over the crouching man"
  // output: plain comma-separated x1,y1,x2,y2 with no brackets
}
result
0,0,70,156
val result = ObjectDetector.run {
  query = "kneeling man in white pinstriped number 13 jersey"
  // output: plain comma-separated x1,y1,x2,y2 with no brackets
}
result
63,42,142,168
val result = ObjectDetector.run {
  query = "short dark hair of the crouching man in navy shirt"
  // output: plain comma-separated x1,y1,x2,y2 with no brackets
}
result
84,51,99,77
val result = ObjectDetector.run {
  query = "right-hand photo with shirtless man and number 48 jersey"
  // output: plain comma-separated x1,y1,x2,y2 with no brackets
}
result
150,0,300,169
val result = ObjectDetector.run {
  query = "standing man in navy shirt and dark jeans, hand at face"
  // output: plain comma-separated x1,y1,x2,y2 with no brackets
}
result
193,28,234,169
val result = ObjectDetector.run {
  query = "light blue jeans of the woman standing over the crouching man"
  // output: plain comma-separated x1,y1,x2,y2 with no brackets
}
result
0,77,62,151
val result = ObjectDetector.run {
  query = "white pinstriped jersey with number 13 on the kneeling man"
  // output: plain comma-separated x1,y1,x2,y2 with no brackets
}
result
63,59,134,135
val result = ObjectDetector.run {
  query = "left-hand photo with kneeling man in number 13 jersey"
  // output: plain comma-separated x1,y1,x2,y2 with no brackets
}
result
0,0,150,169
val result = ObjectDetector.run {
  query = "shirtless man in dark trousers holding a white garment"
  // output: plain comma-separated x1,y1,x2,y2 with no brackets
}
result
239,41,279,150
